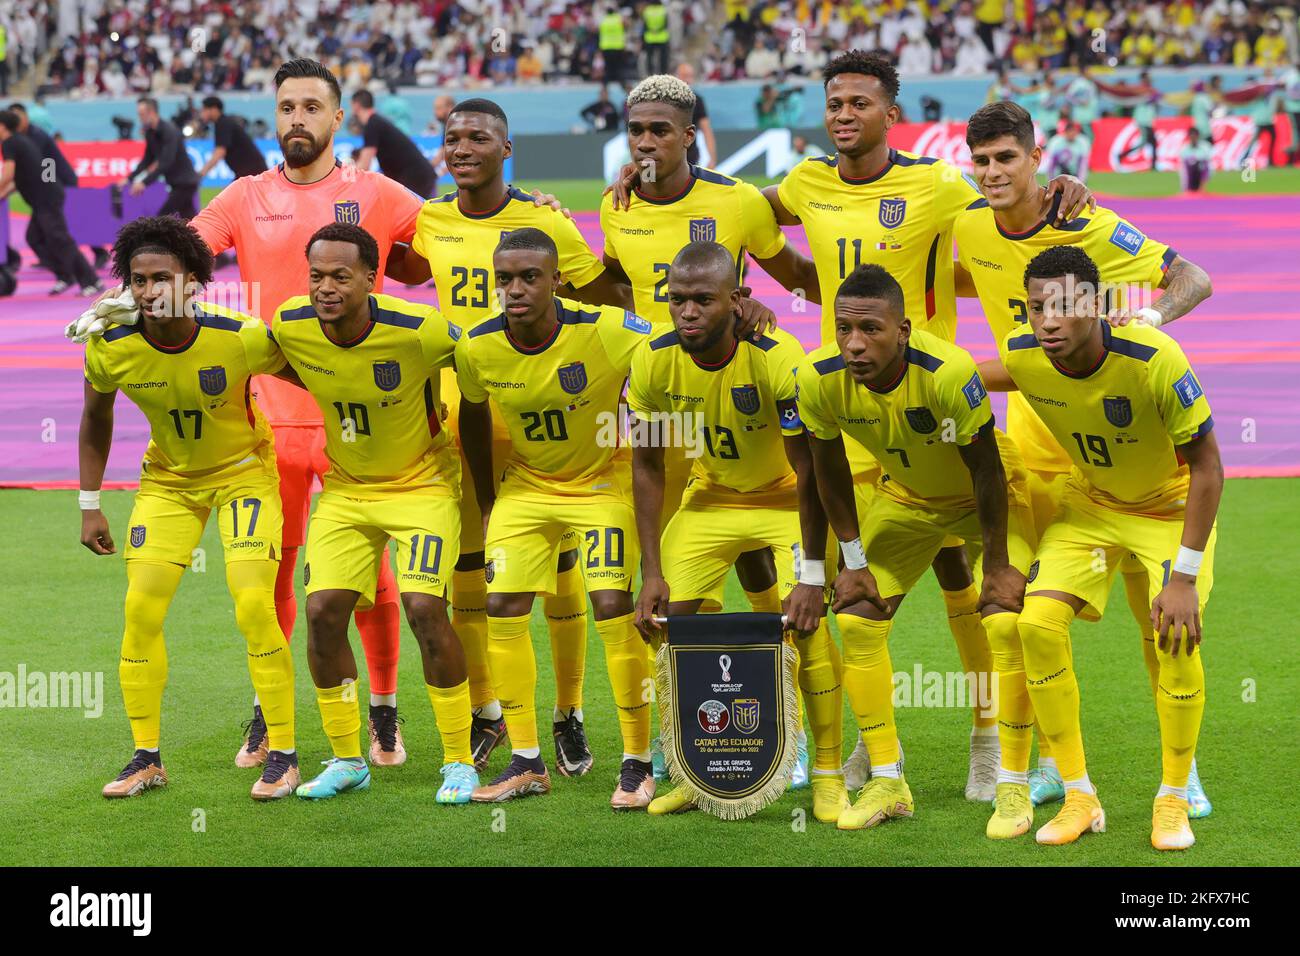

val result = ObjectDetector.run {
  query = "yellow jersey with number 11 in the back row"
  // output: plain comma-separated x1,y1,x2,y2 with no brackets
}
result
777,150,980,343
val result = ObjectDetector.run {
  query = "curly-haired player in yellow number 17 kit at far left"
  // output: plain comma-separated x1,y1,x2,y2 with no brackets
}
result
78,216,299,800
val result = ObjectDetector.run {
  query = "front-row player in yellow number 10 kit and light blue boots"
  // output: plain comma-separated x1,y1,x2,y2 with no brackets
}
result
270,222,478,804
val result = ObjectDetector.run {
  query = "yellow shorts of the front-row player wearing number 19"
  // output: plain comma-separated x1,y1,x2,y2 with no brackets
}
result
1026,485,1218,620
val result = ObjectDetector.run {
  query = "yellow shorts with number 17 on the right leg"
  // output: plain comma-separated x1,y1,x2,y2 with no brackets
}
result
125,471,285,567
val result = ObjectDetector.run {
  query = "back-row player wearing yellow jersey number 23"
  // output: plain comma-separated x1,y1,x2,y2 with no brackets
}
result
411,99,632,777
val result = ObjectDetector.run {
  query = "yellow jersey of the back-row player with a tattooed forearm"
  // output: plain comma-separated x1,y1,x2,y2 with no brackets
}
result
954,196,1178,472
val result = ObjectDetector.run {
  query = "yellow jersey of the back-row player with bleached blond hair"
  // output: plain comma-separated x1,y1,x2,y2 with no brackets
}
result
601,166,785,333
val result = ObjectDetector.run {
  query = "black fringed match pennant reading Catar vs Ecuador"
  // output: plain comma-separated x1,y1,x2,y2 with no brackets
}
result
657,614,798,819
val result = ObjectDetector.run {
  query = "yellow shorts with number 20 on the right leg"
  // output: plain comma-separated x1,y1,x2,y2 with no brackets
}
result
488,483,641,594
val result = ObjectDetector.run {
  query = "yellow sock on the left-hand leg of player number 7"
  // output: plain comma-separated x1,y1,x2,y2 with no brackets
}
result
835,614,898,767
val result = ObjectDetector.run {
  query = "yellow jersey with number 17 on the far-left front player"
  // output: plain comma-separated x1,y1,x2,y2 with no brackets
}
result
86,302,285,490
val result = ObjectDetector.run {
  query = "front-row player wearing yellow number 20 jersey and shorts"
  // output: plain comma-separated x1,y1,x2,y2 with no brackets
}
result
456,226,655,809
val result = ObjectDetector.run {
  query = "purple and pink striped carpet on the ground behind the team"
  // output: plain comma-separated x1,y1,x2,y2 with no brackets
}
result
0,195,1300,486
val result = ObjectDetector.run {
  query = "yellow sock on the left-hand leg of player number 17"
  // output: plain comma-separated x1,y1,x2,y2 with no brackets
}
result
117,561,185,749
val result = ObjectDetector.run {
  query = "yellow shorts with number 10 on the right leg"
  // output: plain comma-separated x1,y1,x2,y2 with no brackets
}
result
303,492,460,607
